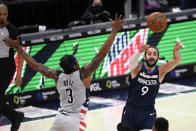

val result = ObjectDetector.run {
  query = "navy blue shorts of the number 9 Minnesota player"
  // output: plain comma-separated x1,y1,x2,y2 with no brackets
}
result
121,106,157,131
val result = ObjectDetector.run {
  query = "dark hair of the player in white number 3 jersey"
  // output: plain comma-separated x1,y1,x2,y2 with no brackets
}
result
60,55,76,74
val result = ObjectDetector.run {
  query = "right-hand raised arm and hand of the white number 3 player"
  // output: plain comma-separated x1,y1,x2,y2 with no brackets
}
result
81,14,125,79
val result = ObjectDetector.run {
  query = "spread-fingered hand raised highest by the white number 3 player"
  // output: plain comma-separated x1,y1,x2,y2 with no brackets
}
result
109,14,126,32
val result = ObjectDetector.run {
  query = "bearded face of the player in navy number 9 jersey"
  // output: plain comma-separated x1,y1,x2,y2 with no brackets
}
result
144,48,159,67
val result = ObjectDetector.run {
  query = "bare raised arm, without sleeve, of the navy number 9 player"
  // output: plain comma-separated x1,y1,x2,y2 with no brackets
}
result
159,41,182,75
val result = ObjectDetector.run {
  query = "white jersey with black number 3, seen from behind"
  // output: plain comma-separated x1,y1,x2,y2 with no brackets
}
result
57,70,86,113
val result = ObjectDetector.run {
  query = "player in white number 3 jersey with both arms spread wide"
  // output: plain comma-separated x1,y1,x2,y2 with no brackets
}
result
4,14,125,131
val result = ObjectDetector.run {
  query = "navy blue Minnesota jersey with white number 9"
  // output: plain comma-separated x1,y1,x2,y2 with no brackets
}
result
126,63,160,110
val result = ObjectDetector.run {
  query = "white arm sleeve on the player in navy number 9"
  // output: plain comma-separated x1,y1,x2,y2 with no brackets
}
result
129,51,142,70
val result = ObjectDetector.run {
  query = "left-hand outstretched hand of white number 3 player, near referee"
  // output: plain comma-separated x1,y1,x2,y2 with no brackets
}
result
3,36,20,48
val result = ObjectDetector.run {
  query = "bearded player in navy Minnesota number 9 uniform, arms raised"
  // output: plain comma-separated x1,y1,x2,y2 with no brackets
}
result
121,42,181,131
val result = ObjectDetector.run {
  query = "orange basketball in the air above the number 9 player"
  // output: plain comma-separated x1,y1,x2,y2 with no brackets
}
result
147,12,167,32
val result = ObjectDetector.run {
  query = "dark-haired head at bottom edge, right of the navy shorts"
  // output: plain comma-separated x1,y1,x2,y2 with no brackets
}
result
154,117,169,131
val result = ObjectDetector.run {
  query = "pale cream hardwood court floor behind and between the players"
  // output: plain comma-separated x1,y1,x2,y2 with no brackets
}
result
0,83,196,131
